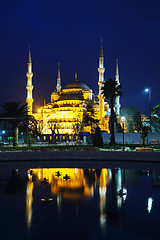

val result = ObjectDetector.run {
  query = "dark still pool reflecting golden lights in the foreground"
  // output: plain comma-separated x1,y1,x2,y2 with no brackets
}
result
0,168,160,240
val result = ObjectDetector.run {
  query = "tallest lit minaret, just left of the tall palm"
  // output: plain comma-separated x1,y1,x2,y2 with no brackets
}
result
98,38,105,120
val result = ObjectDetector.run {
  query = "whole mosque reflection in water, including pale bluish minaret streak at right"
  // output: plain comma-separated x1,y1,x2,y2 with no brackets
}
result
26,168,127,230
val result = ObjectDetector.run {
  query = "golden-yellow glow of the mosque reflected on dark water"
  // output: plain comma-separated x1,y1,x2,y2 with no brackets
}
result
26,168,111,235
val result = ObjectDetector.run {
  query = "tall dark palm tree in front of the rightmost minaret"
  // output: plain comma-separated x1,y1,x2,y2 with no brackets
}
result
102,78,122,145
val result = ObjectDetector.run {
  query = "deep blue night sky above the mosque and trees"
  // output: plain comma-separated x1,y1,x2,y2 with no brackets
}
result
0,0,160,114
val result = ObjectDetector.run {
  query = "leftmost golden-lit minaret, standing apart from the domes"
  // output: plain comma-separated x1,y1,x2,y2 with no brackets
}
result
26,45,33,114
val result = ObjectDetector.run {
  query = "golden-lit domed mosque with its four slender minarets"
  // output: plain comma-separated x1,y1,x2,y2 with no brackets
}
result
26,40,120,137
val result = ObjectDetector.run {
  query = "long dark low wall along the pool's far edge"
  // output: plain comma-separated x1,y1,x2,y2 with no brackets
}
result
0,151,160,163
